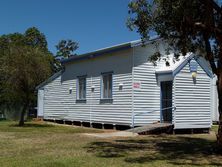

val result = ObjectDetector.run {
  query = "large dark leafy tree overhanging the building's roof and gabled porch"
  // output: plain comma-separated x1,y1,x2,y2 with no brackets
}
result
127,0,222,148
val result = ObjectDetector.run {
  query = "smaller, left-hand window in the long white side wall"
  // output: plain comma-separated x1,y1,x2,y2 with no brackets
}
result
77,77,86,100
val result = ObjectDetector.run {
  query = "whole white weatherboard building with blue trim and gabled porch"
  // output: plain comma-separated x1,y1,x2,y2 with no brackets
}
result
38,39,215,129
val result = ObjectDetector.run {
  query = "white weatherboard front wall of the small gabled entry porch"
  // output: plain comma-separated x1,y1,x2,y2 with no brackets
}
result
174,61,212,129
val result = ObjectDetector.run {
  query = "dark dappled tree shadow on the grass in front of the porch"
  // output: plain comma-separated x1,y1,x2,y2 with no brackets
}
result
87,136,222,166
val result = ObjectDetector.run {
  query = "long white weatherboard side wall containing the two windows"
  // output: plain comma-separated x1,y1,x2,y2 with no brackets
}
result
44,49,132,125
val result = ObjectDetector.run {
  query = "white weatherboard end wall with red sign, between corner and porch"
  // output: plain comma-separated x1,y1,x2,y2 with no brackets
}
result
133,43,164,126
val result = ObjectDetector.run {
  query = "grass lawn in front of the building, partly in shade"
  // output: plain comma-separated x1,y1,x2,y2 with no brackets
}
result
0,121,222,167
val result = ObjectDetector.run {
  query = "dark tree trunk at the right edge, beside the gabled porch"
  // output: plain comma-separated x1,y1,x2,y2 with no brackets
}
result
217,72,222,150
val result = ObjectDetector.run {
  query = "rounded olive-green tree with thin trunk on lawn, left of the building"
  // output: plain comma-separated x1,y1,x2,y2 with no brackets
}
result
1,45,51,126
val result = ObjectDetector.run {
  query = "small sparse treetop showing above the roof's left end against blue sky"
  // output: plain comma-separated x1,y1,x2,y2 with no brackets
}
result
56,40,79,59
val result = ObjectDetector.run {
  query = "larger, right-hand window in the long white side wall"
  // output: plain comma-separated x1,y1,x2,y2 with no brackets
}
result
101,73,113,99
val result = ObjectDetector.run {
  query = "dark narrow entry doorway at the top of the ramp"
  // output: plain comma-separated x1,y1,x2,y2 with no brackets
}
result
161,81,173,122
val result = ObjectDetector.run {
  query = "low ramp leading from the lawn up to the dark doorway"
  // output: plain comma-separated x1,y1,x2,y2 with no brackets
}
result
127,123,173,135
